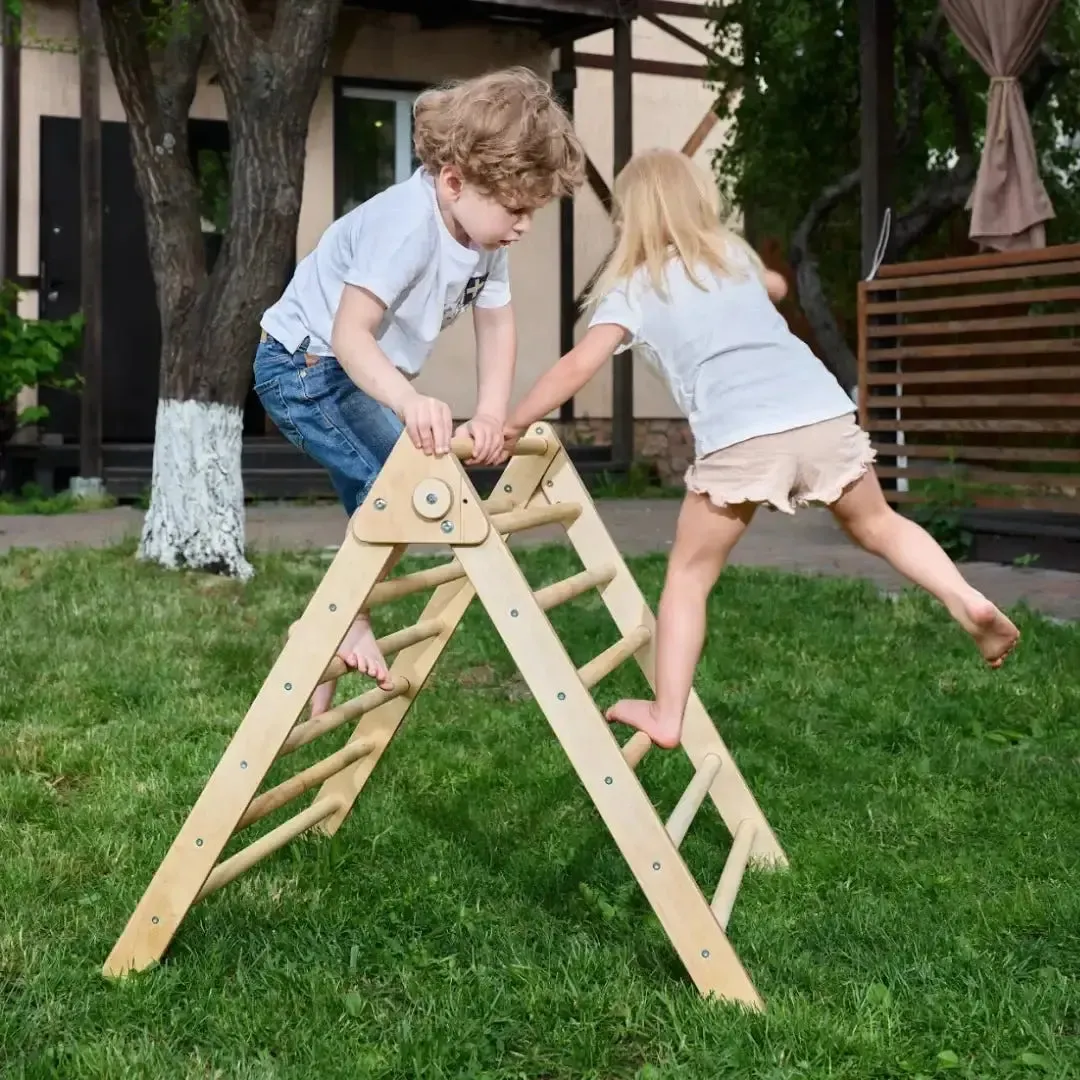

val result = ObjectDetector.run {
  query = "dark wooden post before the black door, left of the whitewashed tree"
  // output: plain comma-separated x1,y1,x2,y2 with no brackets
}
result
79,0,105,482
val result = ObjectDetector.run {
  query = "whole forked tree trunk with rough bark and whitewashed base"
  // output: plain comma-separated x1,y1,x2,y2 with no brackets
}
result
100,0,340,580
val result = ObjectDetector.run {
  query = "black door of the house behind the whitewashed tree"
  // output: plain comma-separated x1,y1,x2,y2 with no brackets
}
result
40,117,265,443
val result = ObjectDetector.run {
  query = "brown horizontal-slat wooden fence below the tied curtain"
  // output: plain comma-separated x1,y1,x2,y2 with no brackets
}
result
859,244,1080,513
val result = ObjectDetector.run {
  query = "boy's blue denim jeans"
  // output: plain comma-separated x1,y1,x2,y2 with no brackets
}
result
254,334,404,515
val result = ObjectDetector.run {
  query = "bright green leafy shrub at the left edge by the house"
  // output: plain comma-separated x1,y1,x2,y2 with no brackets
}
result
0,281,83,442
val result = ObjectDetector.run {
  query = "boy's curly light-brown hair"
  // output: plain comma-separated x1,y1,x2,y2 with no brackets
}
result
413,67,585,207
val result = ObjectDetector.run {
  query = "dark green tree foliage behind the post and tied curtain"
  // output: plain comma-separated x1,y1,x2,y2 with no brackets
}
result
712,0,1080,326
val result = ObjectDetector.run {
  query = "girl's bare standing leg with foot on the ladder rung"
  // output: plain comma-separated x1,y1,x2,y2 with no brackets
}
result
607,492,756,748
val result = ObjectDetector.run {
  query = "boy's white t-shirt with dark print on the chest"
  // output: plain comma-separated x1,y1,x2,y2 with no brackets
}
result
260,168,510,376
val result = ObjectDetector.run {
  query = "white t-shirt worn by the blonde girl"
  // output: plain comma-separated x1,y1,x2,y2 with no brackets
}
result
590,251,855,457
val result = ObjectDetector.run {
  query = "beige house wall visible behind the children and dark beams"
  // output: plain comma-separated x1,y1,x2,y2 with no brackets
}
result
8,0,719,442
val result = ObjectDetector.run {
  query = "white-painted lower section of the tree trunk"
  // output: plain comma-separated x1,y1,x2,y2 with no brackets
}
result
138,399,255,581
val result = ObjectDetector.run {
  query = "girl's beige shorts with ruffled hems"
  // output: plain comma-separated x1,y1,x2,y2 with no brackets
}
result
686,413,876,514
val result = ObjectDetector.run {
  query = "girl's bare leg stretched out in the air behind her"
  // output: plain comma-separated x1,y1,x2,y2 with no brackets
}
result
829,470,1020,667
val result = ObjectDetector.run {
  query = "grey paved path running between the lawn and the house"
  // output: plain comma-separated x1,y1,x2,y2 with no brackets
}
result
0,499,1080,621
